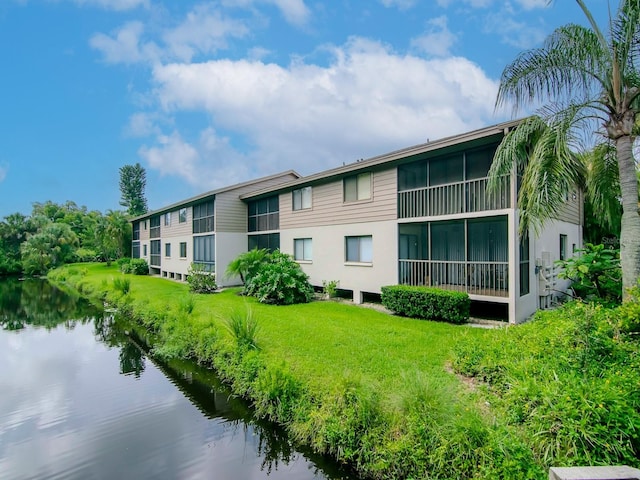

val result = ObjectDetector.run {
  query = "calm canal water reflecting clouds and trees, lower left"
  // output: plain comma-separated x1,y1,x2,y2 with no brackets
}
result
0,280,349,480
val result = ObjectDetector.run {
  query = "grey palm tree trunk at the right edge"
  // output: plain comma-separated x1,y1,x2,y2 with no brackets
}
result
616,135,640,302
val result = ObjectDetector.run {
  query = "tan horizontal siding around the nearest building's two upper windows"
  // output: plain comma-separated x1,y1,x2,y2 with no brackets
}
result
280,168,397,229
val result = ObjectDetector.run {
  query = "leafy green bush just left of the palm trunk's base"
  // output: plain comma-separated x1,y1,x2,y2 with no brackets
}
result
556,243,622,304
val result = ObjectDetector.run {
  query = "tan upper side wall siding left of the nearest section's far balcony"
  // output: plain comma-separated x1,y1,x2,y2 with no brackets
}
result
216,174,297,232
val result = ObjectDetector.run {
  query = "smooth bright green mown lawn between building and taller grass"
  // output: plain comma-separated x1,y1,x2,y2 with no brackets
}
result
61,264,487,401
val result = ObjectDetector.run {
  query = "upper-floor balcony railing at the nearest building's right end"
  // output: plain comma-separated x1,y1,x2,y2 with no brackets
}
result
398,175,511,218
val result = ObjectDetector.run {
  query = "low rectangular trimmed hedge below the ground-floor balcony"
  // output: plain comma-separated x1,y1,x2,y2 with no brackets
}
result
382,285,471,323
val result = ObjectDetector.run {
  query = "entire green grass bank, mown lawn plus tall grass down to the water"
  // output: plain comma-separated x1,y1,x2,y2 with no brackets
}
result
50,264,637,479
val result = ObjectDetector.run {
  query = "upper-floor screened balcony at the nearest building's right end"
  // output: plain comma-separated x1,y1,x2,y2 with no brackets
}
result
398,145,511,218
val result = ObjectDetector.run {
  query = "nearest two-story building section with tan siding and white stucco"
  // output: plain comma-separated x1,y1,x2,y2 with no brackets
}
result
242,122,582,322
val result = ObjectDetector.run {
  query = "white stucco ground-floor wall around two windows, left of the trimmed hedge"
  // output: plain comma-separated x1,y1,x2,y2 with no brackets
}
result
280,221,398,302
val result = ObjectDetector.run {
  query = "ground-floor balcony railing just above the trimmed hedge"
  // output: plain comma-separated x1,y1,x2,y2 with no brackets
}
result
398,260,509,297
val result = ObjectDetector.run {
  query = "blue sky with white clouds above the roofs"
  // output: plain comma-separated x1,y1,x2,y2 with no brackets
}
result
0,0,617,218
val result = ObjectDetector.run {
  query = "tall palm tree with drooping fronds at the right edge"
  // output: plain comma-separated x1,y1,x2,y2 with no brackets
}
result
490,0,640,299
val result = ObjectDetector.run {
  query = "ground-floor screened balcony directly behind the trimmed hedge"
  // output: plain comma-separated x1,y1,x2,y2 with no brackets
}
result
398,216,509,297
